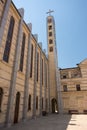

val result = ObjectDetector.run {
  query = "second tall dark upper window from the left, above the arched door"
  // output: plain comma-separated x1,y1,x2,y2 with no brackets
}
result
19,33,26,71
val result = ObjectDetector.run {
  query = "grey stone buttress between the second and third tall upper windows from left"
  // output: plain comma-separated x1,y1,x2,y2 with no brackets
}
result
23,24,32,121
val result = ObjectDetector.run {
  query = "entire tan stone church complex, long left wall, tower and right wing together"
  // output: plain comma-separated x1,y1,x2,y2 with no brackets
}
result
0,0,87,126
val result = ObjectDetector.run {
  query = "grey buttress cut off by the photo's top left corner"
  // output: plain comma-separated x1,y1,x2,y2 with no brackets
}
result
0,0,11,47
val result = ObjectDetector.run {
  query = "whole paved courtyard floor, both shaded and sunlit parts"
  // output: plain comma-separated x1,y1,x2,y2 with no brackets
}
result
0,114,87,130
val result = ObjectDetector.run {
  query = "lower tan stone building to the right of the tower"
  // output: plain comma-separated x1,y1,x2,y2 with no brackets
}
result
60,59,87,113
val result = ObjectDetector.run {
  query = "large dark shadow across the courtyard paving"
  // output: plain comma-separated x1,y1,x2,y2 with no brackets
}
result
0,114,72,130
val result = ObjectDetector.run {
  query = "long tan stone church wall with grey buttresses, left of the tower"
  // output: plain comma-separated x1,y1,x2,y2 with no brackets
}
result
0,0,49,125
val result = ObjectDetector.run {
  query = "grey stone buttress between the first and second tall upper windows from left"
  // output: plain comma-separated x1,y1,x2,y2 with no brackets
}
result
5,9,24,126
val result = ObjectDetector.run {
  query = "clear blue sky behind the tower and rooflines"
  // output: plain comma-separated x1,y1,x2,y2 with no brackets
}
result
13,0,87,68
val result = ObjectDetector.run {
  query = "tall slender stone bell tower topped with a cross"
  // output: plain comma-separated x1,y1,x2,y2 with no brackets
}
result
47,10,61,113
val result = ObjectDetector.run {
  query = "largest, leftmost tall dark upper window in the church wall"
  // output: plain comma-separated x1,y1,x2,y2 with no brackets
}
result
3,16,15,62
